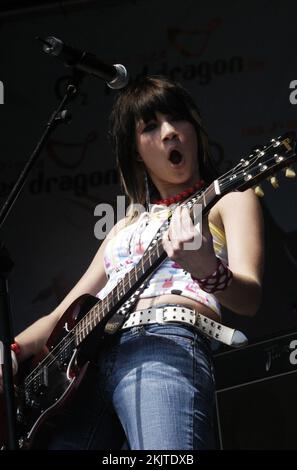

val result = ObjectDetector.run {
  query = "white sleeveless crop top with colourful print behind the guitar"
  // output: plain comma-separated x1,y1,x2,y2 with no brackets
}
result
97,205,228,315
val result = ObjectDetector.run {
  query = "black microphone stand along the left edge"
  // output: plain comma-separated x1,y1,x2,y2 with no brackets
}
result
0,70,85,450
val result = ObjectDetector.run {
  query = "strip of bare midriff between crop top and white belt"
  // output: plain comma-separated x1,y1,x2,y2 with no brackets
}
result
134,294,220,321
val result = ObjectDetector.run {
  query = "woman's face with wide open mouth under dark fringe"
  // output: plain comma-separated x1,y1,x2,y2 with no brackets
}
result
136,112,199,197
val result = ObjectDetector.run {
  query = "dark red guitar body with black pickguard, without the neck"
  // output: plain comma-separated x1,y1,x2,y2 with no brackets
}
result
0,295,103,448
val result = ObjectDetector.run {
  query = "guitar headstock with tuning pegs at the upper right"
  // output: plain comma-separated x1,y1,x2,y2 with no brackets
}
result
218,132,297,196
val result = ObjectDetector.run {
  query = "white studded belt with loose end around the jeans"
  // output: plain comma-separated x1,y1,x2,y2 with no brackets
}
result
122,305,248,347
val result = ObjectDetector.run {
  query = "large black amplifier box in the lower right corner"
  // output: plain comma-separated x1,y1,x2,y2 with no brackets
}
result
214,331,297,449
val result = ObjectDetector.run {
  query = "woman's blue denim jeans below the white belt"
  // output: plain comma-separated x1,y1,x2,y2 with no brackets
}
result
49,324,215,450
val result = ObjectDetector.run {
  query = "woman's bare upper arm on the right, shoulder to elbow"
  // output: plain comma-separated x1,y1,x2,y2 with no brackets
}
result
216,190,264,315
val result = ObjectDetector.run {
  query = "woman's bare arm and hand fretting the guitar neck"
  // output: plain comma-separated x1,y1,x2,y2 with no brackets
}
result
163,190,264,315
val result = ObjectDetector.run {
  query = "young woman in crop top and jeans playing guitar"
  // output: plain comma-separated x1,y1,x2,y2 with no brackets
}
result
0,77,263,450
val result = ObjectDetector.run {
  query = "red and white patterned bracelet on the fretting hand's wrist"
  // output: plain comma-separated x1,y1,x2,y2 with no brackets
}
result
192,258,233,294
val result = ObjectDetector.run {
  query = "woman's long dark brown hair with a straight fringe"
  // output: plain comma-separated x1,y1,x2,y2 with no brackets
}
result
109,76,217,218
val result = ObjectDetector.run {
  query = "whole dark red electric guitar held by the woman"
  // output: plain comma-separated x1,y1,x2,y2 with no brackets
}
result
0,132,297,449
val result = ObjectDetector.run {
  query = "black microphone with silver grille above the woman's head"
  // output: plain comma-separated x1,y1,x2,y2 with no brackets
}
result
37,36,129,89
